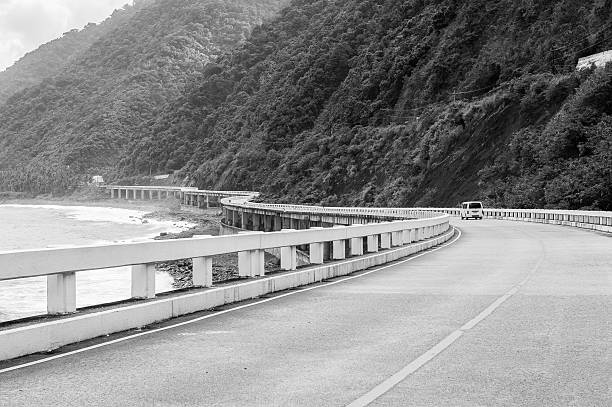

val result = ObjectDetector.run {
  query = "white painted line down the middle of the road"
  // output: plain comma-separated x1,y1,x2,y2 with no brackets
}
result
347,245,544,407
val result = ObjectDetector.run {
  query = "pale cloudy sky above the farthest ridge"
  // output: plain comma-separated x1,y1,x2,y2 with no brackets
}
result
0,0,131,71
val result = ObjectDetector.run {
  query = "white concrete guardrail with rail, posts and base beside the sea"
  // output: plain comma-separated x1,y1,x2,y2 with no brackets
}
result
0,196,454,360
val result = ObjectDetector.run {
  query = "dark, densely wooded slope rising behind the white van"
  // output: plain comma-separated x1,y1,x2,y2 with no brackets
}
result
0,0,612,210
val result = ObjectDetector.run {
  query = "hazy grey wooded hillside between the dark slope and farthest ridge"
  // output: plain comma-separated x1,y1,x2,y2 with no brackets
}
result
0,0,283,192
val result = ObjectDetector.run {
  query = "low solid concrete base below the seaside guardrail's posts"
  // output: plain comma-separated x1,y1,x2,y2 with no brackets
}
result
0,229,454,360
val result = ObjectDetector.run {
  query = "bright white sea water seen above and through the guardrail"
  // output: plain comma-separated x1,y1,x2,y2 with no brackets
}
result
0,205,191,322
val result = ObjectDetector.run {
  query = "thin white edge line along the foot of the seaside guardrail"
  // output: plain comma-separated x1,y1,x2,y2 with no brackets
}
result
0,227,461,374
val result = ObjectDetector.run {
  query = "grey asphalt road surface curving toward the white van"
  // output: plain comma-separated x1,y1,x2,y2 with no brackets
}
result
0,220,612,406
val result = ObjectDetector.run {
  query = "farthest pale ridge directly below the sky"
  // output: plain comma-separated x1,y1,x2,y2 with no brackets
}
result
0,1,144,104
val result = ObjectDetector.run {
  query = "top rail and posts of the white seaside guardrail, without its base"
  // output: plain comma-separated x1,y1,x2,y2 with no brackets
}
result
0,215,450,314
